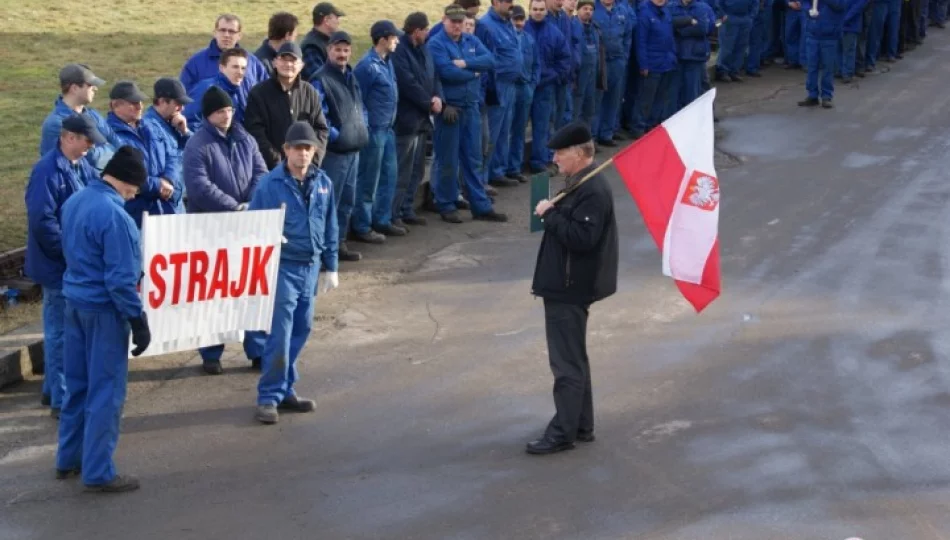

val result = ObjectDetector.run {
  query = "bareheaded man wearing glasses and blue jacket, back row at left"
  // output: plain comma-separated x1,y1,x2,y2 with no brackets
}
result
179,13,268,93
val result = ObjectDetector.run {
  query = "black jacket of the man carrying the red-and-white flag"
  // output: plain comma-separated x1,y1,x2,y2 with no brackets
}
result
531,165,619,305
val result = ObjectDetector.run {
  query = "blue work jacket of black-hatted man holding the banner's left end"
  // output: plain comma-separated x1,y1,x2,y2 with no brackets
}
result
63,180,142,319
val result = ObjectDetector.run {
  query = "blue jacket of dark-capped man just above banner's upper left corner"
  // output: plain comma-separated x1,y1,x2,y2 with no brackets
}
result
106,112,185,227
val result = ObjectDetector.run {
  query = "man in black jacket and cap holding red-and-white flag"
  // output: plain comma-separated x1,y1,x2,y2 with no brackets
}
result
526,122,619,455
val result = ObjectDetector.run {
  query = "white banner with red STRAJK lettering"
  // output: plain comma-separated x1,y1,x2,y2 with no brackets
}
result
130,208,284,356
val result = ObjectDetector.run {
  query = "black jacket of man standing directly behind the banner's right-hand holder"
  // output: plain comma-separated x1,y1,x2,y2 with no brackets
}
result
244,77,330,169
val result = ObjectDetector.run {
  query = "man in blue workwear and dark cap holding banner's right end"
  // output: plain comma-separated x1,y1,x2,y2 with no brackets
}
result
250,122,340,424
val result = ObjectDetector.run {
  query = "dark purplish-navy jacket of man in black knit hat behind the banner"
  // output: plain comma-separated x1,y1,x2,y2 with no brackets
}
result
184,124,267,213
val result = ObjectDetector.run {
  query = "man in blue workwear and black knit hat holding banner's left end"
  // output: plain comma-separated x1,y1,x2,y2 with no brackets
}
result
56,146,151,492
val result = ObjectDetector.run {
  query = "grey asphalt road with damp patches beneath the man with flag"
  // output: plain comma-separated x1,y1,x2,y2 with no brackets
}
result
0,34,950,540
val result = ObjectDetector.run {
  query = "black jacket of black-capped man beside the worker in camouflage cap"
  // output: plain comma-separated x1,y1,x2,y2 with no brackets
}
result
392,39,442,135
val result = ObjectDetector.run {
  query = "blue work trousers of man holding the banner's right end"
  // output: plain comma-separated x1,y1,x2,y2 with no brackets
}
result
257,261,320,405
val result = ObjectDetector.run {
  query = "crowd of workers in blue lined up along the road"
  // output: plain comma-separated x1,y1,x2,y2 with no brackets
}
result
25,0,948,491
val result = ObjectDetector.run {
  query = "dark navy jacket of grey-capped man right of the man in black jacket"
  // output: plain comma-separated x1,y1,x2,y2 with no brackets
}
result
313,65,370,154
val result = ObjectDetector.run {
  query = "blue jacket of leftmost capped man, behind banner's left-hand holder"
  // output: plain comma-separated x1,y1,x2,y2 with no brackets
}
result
23,148,99,289
